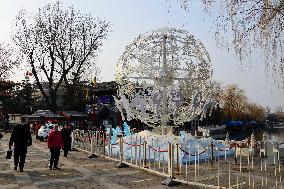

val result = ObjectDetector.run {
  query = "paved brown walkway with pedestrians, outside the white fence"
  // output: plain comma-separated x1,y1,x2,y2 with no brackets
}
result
0,134,197,189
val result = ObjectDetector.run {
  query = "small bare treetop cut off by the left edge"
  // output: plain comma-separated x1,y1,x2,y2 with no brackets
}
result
0,43,19,79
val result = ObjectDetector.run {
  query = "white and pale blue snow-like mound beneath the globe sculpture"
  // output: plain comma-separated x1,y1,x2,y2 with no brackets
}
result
106,130,234,163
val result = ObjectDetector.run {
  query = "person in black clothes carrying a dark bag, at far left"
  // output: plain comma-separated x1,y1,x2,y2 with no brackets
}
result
9,117,32,172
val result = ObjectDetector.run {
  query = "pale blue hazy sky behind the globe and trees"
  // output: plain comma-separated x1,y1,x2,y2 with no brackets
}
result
0,0,284,108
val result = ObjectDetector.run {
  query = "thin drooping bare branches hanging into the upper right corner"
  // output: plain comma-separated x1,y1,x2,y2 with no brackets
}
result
173,0,284,88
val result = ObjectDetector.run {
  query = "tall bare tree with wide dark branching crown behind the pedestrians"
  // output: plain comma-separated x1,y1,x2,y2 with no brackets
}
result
13,2,109,111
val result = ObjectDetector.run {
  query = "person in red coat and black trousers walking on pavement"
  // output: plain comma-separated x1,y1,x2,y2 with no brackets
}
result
47,125,64,170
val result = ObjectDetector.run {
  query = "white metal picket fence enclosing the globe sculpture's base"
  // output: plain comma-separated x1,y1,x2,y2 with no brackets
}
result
72,131,283,188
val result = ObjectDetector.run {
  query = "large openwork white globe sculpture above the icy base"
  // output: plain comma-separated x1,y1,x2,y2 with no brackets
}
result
116,28,212,129
